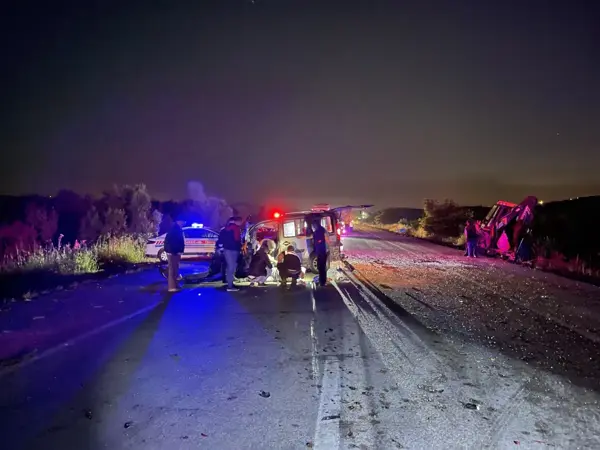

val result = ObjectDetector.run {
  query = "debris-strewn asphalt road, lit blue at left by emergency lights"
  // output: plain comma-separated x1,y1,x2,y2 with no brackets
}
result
0,233,600,450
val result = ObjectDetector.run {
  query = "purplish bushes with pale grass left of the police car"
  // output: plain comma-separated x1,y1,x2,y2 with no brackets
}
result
0,185,162,275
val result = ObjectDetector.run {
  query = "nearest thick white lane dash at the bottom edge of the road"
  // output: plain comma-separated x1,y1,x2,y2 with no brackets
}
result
313,358,342,450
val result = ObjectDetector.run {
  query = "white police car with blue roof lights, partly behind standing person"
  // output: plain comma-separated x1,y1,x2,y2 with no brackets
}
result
146,223,219,262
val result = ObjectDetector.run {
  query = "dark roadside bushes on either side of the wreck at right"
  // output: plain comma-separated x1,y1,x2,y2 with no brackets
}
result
365,197,600,279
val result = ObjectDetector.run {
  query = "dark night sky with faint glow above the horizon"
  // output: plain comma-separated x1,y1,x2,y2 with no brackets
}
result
0,0,600,206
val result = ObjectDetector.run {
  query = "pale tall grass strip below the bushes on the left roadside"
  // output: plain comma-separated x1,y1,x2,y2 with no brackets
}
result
0,236,146,275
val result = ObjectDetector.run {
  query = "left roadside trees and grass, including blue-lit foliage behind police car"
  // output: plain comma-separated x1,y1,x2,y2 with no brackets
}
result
0,182,232,297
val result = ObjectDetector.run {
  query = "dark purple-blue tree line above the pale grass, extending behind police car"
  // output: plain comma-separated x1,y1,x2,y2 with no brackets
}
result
0,182,233,261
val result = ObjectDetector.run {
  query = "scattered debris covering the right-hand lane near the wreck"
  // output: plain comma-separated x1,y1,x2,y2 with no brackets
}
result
346,238,600,389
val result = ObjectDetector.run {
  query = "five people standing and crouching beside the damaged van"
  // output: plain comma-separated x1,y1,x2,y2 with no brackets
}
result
164,216,328,292
